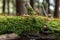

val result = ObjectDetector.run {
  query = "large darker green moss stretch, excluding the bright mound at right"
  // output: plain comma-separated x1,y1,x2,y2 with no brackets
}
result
0,16,44,34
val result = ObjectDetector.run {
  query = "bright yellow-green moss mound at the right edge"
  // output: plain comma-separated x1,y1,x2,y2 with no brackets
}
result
47,20,60,33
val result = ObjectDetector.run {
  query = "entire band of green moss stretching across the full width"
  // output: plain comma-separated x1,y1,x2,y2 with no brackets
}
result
0,16,60,34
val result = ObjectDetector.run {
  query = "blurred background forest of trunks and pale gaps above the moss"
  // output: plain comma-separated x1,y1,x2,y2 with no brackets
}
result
0,0,60,18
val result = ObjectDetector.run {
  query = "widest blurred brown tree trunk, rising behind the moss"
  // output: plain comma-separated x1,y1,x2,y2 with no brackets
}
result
16,0,26,16
